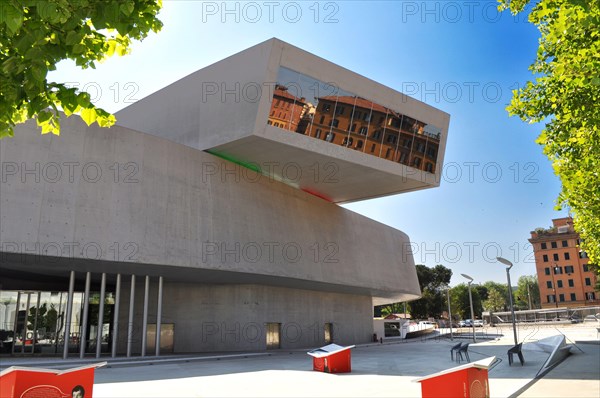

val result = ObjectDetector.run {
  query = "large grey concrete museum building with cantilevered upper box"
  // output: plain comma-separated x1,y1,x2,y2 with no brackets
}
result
0,39,449,356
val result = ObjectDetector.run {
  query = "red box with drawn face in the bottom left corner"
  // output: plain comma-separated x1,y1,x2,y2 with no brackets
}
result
0,362,106,398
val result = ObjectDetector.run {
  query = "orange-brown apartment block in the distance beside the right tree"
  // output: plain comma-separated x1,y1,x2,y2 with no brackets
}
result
529,217,600,308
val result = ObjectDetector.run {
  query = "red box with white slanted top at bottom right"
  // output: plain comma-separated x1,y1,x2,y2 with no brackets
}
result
414,357,496,398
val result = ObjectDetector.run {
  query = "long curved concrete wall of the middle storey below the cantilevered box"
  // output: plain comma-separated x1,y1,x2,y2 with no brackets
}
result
0,118,420,304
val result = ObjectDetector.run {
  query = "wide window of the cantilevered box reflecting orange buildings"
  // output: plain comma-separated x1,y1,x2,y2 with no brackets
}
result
267,67,441,173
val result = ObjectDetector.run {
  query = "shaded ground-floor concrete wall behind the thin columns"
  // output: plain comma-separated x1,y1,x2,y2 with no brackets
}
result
118,283,373,355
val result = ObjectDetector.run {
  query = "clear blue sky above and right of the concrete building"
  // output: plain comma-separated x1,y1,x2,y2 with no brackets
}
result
50,0,567,285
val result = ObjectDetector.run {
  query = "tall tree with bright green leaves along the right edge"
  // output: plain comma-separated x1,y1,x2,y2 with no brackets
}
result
498,0,600,270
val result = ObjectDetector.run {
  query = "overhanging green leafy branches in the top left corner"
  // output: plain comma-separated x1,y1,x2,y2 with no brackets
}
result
0,0,162,139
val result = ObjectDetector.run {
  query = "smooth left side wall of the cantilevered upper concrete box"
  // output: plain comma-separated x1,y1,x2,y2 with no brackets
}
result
116,42,272,149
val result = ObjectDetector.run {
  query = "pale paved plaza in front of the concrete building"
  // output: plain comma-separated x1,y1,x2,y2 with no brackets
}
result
2,324,600,398
